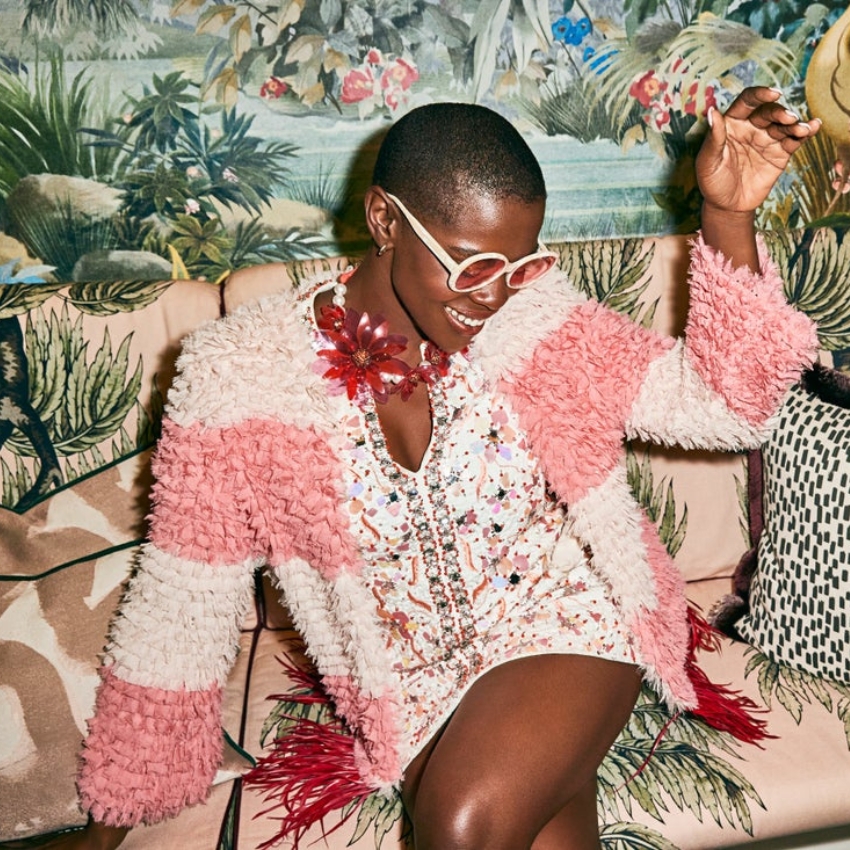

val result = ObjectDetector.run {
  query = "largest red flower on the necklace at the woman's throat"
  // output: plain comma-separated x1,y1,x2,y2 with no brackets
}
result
318,308,410,402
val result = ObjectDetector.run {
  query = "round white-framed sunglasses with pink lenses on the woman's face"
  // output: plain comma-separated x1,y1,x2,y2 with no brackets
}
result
387,192,558,292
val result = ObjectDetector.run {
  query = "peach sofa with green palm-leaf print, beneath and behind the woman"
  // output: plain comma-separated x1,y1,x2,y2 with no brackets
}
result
0,228,850,850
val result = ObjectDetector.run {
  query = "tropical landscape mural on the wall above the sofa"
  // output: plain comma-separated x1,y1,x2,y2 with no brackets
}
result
0,0,850,280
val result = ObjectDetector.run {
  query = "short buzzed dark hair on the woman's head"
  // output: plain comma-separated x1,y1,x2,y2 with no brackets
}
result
372,103,546,222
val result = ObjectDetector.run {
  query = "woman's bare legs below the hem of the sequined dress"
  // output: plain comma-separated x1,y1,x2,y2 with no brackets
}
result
402,655,640,850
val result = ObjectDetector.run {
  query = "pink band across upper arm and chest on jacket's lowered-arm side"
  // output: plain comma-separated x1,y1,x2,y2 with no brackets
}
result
149,419,360,578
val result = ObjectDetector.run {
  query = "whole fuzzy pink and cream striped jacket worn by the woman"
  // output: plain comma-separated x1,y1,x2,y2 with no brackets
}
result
79,235,817,826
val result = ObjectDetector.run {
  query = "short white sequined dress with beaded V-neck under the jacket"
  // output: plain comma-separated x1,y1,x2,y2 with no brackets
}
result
304,280,636,765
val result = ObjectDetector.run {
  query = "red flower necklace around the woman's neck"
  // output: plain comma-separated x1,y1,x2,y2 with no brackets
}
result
317,272,449,403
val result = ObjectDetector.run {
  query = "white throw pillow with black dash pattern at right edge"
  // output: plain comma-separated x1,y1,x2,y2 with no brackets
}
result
736,367,850,682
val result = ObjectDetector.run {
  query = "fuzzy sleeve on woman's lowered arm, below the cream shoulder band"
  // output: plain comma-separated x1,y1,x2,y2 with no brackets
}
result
78,402,265,827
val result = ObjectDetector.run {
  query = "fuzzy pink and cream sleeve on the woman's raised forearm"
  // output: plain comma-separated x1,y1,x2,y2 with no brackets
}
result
626,230,818,450
